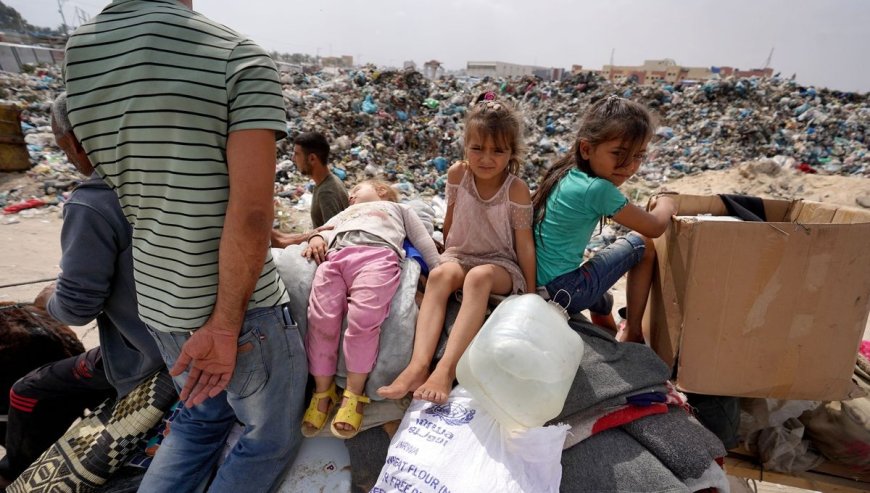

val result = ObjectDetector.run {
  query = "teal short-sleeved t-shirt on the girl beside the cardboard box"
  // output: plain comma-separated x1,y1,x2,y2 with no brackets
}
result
534,168,628,286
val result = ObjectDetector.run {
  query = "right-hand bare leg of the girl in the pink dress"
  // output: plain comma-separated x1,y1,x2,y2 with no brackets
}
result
414,265,513,404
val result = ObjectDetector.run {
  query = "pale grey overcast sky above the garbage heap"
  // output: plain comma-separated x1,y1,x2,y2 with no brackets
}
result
11,0,870,92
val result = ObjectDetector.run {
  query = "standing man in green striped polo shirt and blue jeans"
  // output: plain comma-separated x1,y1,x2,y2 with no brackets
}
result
65,0,307,493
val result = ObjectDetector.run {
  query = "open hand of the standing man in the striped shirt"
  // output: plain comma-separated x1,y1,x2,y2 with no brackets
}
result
169,321,239,407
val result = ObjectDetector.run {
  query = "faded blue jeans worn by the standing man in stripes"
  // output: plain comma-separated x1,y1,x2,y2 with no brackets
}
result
139,306,308,493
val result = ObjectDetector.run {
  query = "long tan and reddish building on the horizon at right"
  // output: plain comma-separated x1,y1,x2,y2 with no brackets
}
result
601,58,773,85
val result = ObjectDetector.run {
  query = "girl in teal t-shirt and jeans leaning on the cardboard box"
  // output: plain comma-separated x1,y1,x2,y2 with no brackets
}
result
532,96,676,342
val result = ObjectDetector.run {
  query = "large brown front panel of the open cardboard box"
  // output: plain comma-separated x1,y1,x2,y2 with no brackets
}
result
677,223,870,400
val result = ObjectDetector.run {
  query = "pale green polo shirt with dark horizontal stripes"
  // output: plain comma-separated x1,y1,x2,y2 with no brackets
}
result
64,0,288,331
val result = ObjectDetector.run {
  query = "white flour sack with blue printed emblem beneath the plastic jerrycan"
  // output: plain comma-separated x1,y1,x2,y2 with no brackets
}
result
372,386,568,493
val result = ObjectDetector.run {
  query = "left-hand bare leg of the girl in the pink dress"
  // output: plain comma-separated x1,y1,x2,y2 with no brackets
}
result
377,262,465,399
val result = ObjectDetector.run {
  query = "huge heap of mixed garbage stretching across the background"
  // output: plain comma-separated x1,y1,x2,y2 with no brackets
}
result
0,66,870,213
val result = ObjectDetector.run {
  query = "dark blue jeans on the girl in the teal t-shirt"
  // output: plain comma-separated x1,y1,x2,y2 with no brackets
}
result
544,233,646,315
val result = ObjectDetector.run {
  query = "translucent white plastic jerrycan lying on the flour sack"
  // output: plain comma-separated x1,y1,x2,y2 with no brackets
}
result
456,294,583,430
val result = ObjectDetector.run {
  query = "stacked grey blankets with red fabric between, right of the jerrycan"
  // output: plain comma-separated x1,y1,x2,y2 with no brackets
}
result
553,321,729,492
